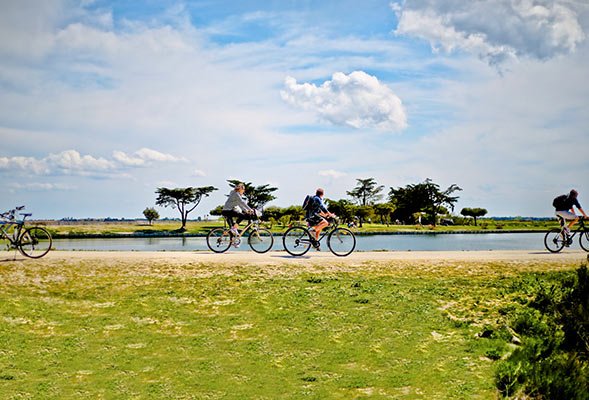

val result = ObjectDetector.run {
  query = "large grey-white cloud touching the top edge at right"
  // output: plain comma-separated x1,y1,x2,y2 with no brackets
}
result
393,0,585,65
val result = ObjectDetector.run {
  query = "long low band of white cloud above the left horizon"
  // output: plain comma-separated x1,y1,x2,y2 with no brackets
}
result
0,148,186,176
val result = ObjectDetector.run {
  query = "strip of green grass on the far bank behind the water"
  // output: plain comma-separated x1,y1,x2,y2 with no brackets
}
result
36,220,558,235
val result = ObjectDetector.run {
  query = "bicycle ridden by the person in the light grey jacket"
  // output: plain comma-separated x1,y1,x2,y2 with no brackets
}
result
207,210,274,253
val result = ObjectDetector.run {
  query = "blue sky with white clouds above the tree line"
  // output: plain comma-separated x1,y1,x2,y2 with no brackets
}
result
0,0,589,218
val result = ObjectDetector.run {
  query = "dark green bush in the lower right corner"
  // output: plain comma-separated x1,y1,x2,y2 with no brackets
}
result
489,266,589,400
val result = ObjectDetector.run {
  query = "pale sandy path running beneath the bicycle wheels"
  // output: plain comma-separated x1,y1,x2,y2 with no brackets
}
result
1,250,589,265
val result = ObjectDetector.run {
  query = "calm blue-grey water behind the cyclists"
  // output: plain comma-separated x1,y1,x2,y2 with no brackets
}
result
53,232,560,251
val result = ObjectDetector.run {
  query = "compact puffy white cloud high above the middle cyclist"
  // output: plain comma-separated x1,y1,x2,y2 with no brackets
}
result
280,71,407,131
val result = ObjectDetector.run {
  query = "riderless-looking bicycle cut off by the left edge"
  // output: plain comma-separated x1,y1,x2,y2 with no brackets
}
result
0,206,53,258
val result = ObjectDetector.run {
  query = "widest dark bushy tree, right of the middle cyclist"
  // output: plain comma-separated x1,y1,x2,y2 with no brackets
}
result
389,178,462,225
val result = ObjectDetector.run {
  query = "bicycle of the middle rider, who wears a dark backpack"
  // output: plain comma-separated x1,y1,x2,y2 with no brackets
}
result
282,218,356,257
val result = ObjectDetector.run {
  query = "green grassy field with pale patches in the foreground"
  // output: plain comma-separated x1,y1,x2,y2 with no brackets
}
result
0,255,578,399
